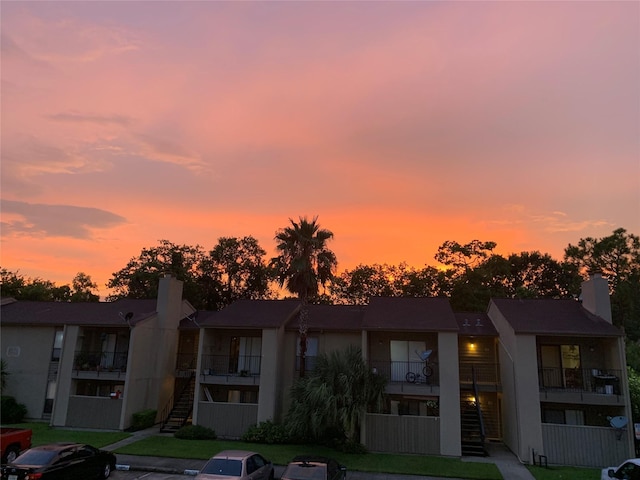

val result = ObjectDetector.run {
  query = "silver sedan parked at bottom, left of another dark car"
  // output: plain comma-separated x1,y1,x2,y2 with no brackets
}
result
196,450,274,480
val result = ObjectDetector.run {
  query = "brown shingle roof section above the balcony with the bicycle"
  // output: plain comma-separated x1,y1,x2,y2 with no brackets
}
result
363,297,458,332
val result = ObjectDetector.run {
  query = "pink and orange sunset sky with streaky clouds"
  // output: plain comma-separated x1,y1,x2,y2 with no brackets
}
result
0,0,640,296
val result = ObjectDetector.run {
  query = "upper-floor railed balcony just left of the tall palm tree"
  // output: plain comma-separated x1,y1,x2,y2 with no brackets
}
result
200,355,262,385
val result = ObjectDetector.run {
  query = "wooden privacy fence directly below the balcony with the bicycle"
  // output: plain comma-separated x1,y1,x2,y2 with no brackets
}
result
365,413,440,455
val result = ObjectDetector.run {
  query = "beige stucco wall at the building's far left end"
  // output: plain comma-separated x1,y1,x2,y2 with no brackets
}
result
0,325,56,419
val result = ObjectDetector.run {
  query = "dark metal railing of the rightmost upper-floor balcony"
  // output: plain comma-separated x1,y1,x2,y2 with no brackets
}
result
538,367,622,395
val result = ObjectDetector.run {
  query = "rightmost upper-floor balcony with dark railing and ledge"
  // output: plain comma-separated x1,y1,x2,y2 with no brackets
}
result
538,367,623,404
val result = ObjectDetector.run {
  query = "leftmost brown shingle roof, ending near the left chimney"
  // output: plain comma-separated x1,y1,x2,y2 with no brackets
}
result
0,299,156,327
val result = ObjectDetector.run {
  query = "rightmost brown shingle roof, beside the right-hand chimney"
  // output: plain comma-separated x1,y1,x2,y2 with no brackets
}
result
491,298,622,337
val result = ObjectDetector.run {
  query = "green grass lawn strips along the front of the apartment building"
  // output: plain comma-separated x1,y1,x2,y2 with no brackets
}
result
13,423,600,480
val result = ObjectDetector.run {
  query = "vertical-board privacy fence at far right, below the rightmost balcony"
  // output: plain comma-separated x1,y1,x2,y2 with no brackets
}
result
542,423,633,468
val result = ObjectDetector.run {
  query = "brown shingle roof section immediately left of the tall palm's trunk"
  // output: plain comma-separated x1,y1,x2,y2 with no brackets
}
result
196,300,300,329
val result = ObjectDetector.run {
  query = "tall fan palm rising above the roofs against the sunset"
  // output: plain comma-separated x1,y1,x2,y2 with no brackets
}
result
271,216,338,377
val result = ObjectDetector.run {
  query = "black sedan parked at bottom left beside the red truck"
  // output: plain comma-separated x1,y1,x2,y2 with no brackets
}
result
2,443,116,480
